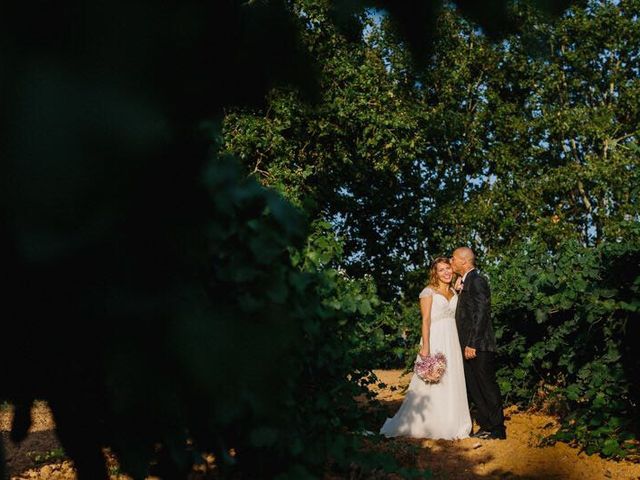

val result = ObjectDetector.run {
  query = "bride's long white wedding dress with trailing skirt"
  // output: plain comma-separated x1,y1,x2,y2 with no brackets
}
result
380,287,471,440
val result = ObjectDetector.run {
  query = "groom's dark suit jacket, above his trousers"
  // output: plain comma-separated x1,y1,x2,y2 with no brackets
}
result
456,270,496,352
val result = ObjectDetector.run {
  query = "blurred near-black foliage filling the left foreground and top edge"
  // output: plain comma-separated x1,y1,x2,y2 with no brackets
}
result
0,0,576,479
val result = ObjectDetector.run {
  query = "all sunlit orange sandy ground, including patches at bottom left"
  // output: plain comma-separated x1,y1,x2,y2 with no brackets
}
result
0,370,640,480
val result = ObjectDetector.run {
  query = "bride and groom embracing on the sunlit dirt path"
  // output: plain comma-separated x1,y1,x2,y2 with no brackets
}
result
380,247,506,439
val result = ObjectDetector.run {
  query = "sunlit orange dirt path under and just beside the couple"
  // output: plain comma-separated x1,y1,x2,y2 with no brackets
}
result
368,370,640,480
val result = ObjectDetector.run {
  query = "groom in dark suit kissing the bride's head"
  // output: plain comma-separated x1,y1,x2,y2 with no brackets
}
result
451,247,507,439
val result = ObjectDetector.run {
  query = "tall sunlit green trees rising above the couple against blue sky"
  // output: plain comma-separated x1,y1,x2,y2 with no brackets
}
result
225,2,640,292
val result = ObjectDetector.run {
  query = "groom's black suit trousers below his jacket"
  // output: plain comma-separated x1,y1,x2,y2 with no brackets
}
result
464,350,505,433
